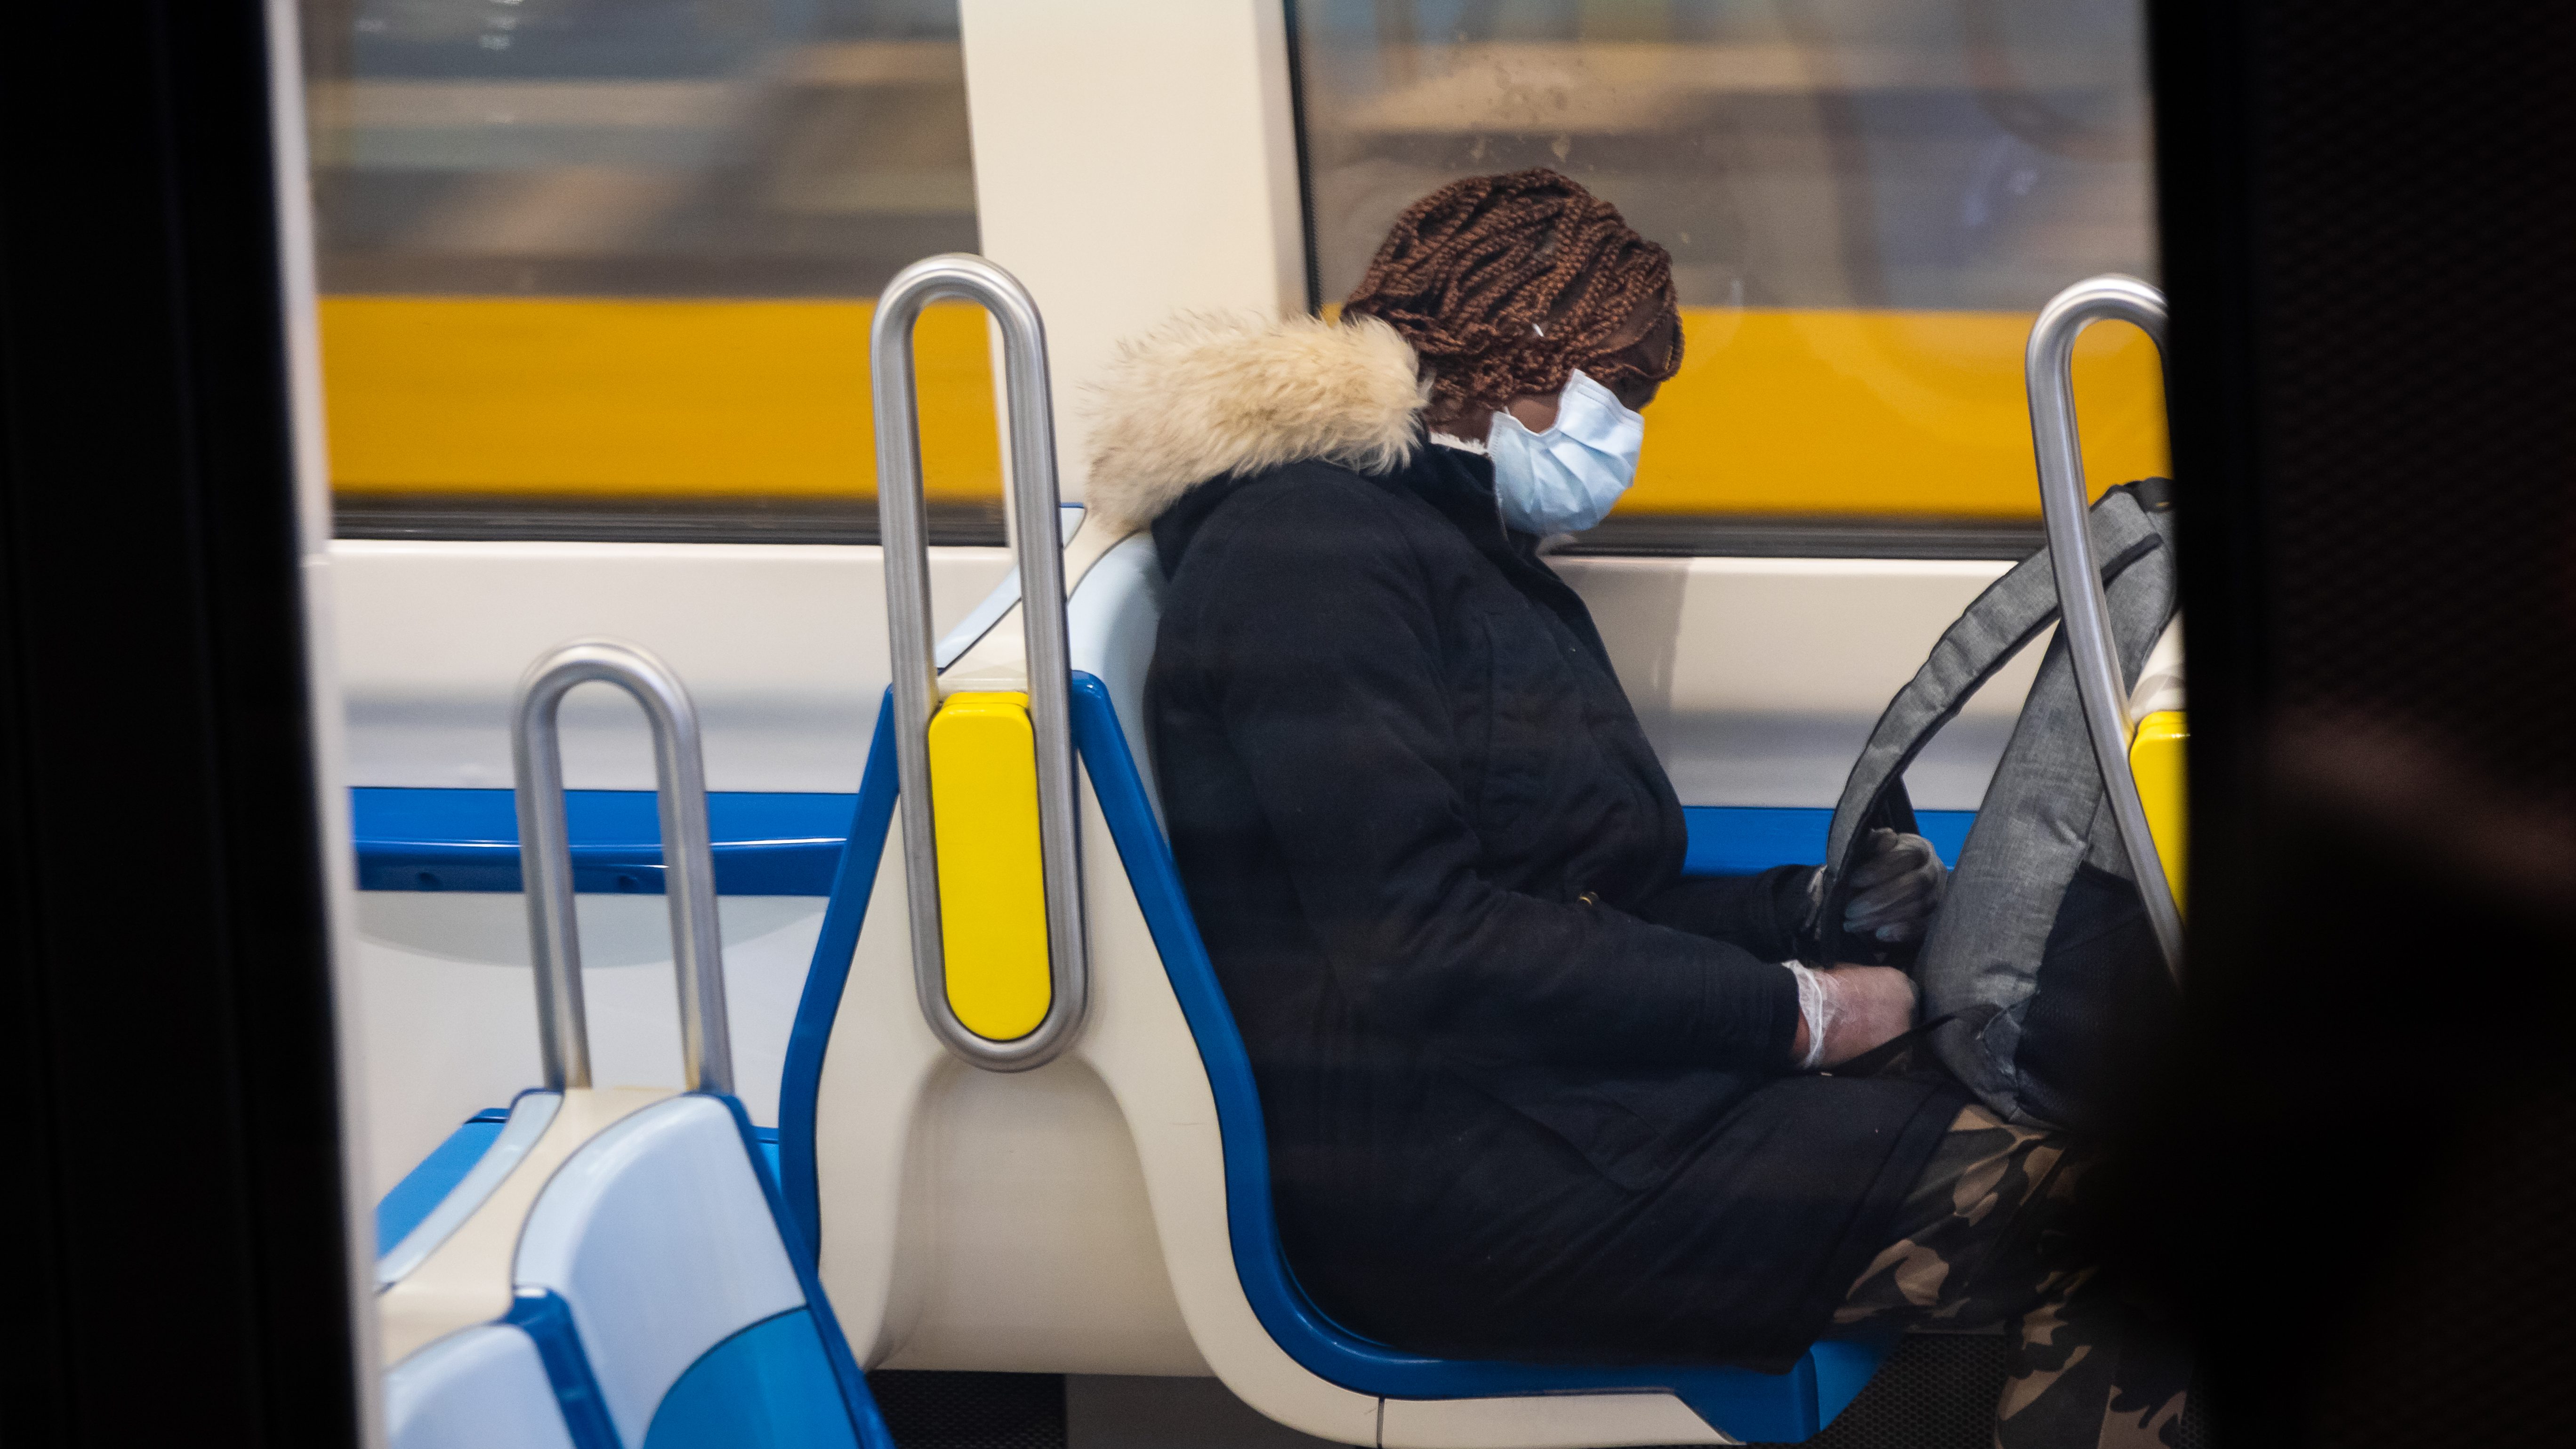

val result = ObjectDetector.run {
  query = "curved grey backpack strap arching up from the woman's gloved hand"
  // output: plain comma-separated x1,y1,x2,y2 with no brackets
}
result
1813,485,2164,967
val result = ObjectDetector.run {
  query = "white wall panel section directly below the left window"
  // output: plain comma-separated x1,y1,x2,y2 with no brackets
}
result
332,539,1010,791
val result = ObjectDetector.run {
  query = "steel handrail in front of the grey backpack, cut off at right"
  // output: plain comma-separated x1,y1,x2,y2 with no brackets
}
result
2022,274,2182,982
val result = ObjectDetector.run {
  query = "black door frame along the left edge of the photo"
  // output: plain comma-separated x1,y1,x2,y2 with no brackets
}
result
0,0,371,1447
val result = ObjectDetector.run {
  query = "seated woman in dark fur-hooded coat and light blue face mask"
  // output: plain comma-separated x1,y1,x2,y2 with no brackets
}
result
1092,170,2179,1447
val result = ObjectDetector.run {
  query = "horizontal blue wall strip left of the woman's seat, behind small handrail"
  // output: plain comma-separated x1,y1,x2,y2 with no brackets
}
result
348,786,850,894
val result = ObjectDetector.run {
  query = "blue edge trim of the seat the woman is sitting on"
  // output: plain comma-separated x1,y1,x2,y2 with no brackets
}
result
1074,673,1893,1441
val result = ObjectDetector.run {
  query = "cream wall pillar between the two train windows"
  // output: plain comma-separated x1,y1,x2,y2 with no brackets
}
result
961,0,1306,500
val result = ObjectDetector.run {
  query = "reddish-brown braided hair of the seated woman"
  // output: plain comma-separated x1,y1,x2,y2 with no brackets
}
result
1342,168,1682,420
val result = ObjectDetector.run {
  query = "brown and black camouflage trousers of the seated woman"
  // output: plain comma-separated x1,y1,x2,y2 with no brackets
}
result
1834,1103,2190,1449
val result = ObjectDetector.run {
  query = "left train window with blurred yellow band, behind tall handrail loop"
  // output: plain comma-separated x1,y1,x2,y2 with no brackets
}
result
304,0,1002,541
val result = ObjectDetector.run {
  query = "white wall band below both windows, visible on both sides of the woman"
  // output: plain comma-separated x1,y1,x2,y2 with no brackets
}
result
332,541,2040,810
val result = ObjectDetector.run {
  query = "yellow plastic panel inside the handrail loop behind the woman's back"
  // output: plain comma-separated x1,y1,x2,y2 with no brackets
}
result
930,693,1054,1042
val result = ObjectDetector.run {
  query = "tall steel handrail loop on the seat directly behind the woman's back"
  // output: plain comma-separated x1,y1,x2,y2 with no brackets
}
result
868,253,1092,1072
